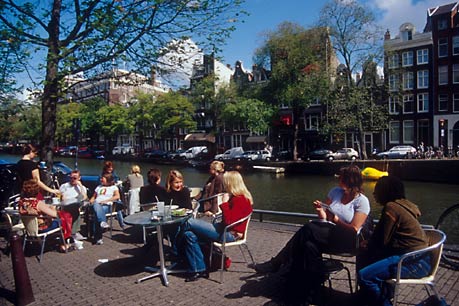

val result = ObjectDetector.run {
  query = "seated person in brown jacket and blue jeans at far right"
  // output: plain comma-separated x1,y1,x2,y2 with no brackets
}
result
359,176,431,305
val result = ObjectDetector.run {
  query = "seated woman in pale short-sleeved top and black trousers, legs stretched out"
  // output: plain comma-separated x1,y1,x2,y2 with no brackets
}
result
254,166,370,302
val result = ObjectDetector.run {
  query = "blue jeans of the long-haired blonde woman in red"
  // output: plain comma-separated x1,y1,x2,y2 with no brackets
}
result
183,219,235,273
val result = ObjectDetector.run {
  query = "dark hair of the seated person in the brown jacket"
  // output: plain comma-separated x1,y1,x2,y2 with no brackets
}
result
374,175,405,205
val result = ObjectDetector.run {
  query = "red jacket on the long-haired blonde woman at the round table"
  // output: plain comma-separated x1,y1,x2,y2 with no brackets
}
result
220,195,253,234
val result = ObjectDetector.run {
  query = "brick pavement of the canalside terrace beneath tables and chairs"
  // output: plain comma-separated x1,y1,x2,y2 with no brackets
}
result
0,221,459,306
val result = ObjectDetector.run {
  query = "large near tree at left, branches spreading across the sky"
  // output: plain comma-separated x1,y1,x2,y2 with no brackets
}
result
0,0,242,163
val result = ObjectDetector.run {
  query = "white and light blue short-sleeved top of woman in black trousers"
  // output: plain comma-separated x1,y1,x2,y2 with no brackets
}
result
328,187,370,223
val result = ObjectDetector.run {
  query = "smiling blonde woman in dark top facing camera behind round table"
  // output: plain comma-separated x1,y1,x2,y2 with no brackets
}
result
166,170,192,209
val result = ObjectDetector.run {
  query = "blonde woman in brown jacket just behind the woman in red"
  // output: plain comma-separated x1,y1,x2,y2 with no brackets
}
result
202,160,225,215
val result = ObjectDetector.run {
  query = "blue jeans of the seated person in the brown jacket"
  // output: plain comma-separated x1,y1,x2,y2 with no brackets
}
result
359,254,431,306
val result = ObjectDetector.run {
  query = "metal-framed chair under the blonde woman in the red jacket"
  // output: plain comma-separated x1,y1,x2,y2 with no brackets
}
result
209,214,255,283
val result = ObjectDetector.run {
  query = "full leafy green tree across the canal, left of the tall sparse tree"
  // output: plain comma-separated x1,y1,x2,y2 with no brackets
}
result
256,22,330,160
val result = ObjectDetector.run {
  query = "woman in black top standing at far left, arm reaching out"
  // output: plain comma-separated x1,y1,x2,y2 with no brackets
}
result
16,144,59,200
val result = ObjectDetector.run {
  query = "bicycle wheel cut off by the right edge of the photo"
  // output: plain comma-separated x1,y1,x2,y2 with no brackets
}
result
435,204,459,270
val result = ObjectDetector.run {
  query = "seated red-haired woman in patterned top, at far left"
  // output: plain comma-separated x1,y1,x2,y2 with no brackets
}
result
18,179,72,251
